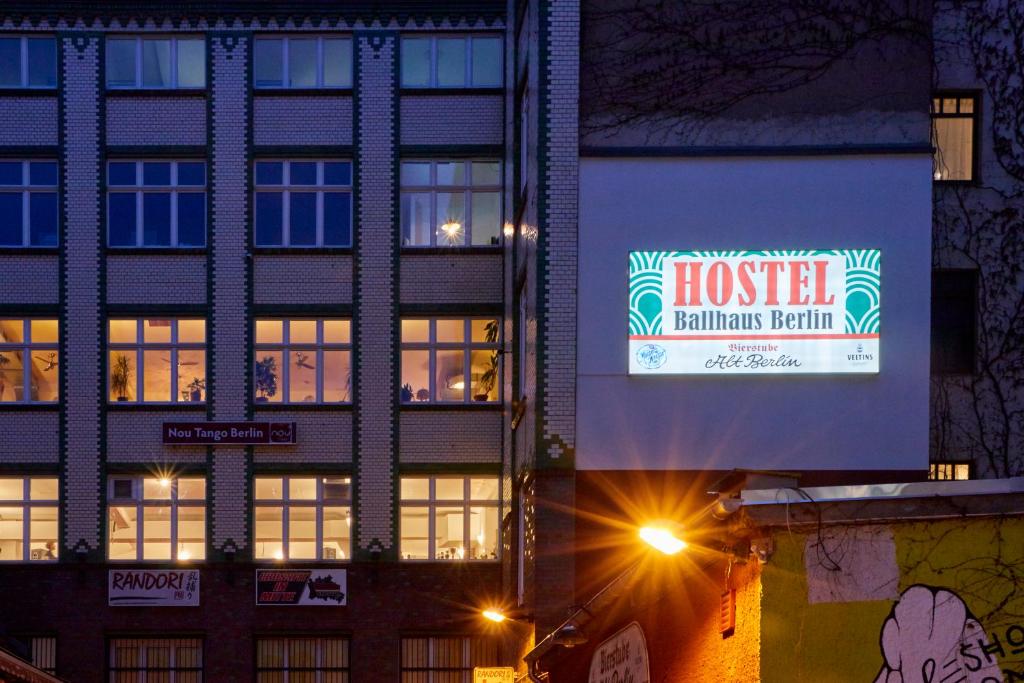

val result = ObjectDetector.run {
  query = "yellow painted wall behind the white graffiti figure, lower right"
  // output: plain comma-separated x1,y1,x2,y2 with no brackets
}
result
761,518,1024,683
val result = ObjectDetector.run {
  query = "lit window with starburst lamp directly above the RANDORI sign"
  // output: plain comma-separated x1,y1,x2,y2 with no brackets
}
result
106,475,206,561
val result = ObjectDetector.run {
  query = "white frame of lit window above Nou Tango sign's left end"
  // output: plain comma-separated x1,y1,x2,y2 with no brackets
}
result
105,315,210,407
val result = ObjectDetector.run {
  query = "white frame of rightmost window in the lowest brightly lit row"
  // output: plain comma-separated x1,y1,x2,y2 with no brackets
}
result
398,474,502,562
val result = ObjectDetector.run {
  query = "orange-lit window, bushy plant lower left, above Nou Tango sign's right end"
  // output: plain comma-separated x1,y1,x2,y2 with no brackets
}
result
253,318,352,403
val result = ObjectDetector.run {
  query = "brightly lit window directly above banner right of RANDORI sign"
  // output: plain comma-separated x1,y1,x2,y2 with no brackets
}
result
253,476,352,560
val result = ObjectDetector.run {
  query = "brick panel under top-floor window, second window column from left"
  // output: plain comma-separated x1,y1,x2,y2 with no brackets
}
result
106,95,206,145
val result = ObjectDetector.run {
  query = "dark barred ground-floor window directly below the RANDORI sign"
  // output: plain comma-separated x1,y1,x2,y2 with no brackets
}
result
108,638,203,683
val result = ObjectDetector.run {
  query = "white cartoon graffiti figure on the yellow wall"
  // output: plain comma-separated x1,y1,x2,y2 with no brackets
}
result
874,586,1004,683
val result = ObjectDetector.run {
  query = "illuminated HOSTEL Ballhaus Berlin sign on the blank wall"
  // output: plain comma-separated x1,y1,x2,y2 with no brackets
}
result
629,249,882,375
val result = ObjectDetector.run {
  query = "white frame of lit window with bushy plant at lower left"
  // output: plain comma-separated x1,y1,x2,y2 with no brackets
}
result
251,315,353,408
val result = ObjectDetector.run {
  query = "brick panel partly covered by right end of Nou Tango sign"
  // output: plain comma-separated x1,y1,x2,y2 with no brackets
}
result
253,409,352,467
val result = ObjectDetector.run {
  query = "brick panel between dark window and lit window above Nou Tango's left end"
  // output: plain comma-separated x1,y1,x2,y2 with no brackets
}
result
106,254,207,305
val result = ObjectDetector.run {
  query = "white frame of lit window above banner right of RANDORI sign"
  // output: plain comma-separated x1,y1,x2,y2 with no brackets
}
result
252,473,352,563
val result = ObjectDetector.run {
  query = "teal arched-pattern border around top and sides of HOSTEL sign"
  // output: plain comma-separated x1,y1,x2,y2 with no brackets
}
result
630,249,882,336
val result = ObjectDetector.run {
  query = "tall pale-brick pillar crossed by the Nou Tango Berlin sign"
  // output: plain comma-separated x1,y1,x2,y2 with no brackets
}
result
208,33,251,552
